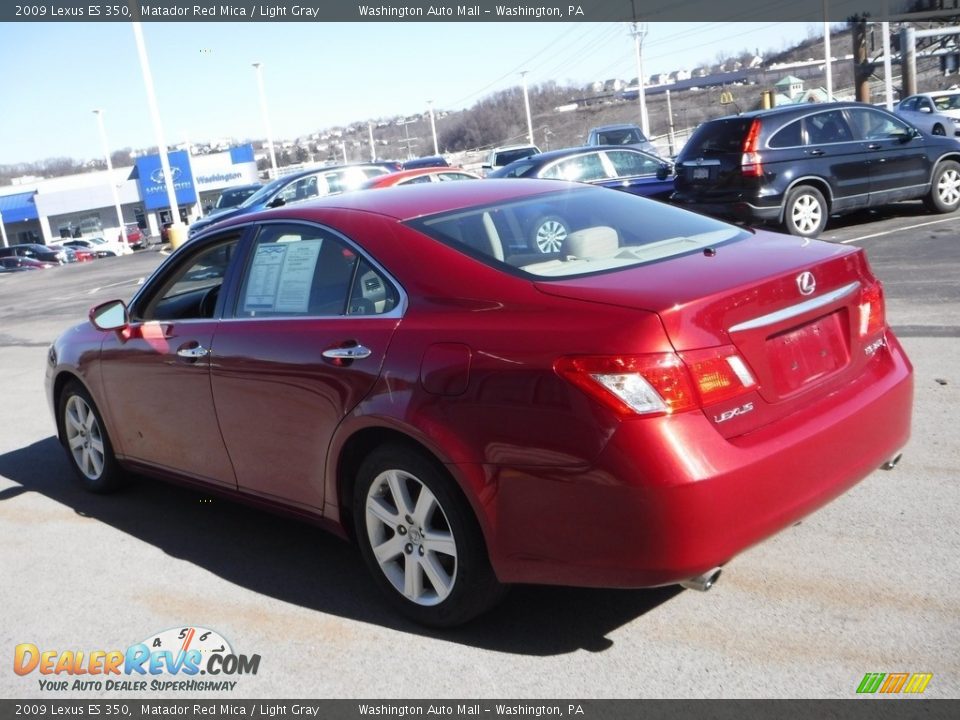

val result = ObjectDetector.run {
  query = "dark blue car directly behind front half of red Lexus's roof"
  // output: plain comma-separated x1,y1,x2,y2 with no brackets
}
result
188,163,391,238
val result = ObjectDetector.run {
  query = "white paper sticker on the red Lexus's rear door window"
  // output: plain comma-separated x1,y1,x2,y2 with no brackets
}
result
243,240,322,313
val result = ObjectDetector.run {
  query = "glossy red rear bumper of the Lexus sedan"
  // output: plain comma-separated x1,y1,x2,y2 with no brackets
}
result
487,334,913,587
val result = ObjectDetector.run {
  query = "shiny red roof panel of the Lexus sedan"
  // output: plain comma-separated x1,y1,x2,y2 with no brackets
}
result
218,178,584,227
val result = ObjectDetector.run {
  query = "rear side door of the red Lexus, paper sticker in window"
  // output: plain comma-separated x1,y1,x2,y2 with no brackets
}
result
212,222,401,508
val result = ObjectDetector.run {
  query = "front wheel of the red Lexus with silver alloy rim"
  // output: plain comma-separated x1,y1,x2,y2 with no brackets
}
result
58,381,126,493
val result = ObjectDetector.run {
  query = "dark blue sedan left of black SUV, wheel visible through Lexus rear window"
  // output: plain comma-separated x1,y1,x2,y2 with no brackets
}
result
487,145,673,254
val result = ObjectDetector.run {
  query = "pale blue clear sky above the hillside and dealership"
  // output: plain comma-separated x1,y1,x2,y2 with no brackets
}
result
0,22,823,165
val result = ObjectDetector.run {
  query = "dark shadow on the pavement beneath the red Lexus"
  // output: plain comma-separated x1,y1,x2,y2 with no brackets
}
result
0,437,682,656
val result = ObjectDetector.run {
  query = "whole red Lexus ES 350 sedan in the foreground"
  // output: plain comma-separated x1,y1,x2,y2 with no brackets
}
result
47,180,912,626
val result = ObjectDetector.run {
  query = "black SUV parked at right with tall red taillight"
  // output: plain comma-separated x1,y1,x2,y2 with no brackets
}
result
671,102,960,237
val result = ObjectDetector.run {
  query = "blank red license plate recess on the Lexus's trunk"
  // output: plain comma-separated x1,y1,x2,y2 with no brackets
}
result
767,312,850,397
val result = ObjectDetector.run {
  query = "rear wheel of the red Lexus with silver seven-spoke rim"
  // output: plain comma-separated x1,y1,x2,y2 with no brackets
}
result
353,445,505,627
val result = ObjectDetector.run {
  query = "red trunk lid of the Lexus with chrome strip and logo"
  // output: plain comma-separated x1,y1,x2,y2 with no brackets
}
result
535,232,882,437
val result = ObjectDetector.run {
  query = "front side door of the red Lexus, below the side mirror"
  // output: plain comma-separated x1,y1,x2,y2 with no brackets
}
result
100,234,244,487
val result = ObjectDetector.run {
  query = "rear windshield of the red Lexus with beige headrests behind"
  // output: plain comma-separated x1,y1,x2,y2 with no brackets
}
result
409,187,749,278
